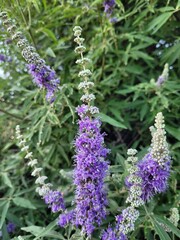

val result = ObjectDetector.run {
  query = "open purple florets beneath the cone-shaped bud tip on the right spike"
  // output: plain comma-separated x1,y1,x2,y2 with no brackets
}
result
138,153,170,201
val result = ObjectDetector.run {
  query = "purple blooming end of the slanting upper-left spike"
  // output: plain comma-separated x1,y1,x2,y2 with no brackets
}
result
28,64,60,102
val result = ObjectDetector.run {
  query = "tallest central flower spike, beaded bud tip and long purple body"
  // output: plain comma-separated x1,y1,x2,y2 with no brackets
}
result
59,26,109,237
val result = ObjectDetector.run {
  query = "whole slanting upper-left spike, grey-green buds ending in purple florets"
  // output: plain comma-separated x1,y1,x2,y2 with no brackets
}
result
0,12,60,102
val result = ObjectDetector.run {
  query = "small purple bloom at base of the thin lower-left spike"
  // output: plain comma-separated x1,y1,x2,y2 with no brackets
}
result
43,190,65,213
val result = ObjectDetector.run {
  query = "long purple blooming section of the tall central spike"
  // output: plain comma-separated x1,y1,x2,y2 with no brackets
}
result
74,111,109,236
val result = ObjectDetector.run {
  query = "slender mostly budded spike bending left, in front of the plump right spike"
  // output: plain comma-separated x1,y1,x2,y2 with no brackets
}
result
102,149,144,240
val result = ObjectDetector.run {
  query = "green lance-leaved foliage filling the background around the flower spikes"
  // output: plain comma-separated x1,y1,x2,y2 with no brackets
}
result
0,0,180,240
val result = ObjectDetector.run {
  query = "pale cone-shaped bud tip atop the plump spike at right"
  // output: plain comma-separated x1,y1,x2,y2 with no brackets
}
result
151,112,169,166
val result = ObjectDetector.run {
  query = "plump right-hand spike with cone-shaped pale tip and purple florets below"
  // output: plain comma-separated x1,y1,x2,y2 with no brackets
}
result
138,112,170,201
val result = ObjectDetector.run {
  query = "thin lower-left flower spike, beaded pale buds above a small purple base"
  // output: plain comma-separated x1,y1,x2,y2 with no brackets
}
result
16,125,65,213
